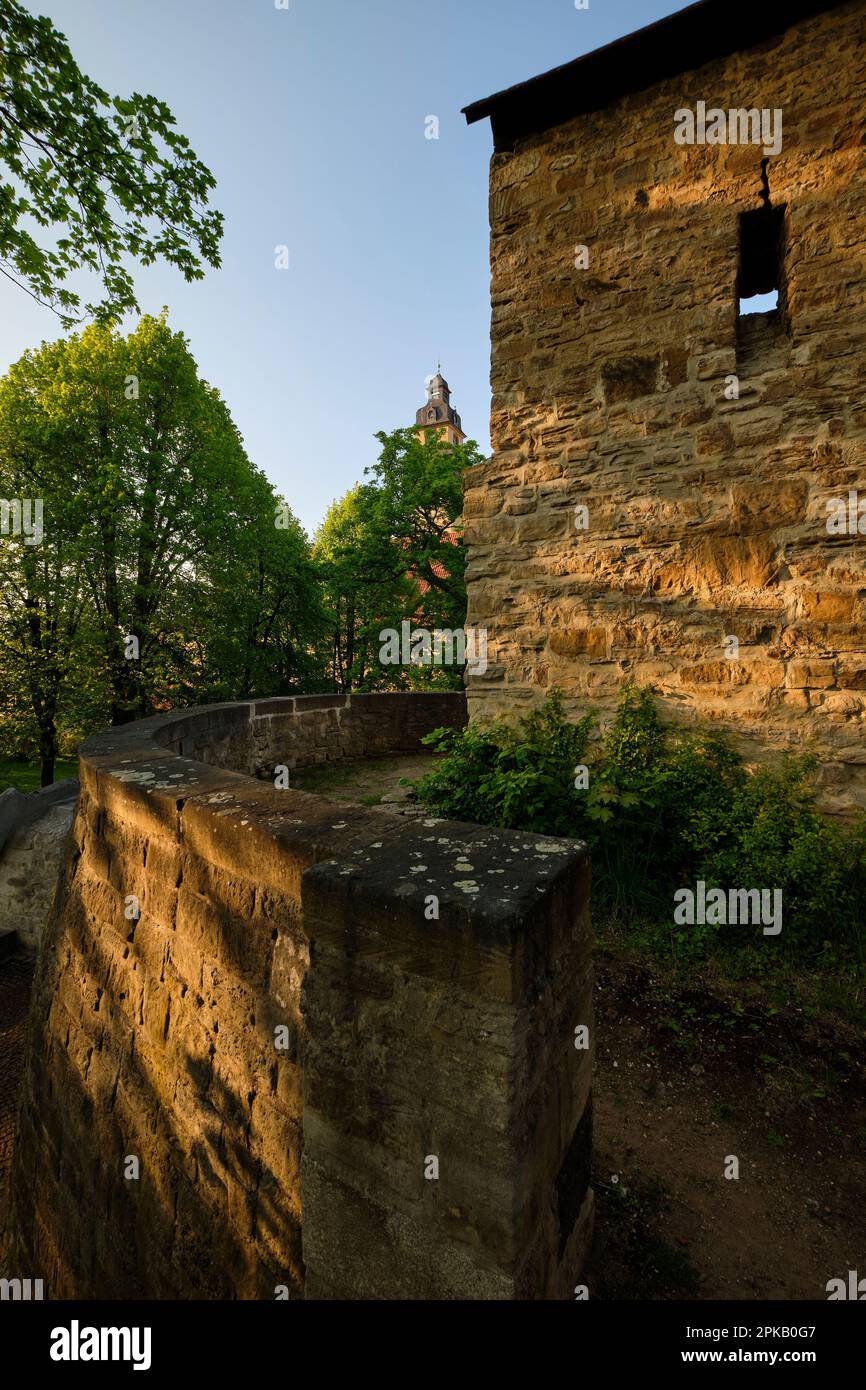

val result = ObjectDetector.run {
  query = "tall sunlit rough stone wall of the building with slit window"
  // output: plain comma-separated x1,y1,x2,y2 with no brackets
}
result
466,3,866,810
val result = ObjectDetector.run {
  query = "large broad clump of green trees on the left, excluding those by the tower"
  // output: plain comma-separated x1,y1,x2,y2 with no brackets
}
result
0,316,324,780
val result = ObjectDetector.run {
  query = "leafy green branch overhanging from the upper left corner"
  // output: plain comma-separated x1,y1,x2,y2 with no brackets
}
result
0,0,222,327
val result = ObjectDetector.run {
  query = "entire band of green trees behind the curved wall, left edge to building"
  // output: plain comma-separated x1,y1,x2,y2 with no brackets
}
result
0,314,480,781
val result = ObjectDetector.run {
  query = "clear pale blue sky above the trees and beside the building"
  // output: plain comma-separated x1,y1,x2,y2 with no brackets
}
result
0,0,684,532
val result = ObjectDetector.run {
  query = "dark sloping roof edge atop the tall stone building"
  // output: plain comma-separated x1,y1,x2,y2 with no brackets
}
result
463,0,842,150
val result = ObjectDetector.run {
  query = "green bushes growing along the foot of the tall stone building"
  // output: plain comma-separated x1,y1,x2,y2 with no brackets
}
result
418,685,866,956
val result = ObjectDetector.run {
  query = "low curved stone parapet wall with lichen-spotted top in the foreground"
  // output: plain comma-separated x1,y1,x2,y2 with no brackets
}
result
4,694,592,1298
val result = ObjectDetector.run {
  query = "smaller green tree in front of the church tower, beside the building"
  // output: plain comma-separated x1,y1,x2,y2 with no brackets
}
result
316,419,481,691
